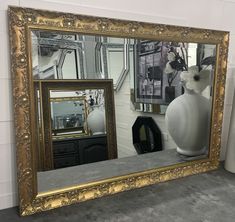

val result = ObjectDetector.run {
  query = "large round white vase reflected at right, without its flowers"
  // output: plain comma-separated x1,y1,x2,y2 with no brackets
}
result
165,90,210,156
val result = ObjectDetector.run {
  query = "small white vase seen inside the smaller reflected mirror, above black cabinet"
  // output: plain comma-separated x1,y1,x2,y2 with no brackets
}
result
87,106,105,135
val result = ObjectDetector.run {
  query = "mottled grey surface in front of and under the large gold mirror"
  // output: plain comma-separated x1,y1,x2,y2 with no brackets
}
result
0,169,235,222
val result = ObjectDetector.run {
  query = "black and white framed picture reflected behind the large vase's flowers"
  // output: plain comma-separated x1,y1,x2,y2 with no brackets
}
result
135,40,186,105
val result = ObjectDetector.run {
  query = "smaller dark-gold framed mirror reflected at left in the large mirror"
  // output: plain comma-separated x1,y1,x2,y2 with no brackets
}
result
34,80,117,173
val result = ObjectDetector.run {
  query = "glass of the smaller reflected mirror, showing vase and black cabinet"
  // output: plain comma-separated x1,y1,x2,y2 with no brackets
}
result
50,89,109,169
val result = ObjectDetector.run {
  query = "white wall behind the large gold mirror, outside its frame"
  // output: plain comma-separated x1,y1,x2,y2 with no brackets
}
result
0,0,235,209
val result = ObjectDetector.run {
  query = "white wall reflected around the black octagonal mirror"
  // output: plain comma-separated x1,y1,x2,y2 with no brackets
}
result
114,74,176,158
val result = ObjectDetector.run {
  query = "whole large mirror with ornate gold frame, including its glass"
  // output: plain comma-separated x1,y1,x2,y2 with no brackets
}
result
9,7,229,215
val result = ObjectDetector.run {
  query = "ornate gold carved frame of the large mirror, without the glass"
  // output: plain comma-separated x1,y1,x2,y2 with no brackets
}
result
8,7,229,215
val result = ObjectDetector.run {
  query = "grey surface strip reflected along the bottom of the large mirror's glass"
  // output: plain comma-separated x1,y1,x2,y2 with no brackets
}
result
37,149,206,192
